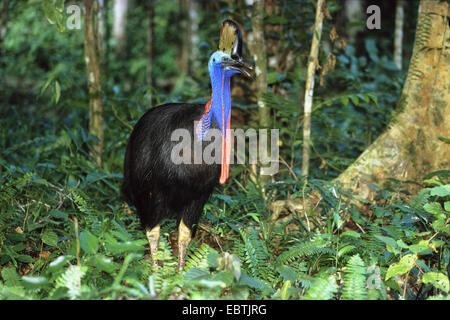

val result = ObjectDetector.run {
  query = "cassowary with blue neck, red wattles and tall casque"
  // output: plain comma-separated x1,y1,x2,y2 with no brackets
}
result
122,20,251,270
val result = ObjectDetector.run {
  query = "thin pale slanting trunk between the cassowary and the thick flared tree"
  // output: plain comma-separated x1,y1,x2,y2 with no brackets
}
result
302,0,325,176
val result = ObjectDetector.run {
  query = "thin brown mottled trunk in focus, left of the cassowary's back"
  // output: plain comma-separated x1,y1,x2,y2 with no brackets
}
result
83,0,103,166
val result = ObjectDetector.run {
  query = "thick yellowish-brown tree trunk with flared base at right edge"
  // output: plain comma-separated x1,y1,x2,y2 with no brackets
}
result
336,0,450,199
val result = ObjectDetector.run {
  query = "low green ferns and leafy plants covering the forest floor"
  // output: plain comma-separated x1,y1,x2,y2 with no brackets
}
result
0,150,450,299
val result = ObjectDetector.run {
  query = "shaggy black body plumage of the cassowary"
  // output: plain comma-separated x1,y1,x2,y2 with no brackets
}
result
122,103,220,232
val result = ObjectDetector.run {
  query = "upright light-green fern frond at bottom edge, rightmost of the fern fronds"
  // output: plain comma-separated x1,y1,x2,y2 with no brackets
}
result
342,254,367,300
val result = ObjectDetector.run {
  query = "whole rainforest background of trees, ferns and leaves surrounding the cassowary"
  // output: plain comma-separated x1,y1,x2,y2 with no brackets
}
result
0,0,450,300
